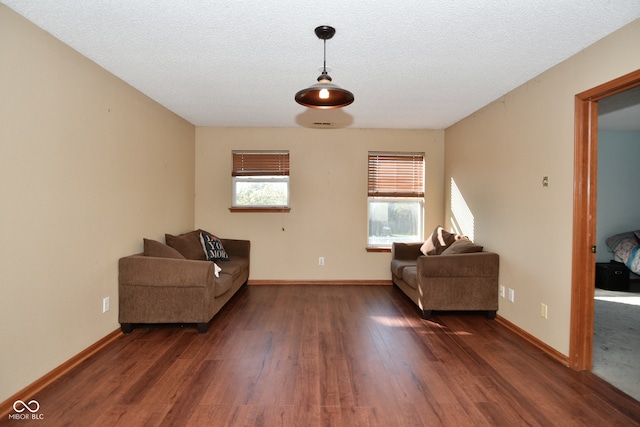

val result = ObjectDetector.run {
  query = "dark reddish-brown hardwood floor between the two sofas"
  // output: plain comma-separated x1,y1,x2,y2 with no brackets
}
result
5,285,640,427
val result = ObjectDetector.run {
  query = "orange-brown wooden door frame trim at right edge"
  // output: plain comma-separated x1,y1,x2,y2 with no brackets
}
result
569,70,640,370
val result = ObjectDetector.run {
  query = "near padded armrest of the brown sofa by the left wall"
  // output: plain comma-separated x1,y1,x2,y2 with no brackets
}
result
118,255,215,288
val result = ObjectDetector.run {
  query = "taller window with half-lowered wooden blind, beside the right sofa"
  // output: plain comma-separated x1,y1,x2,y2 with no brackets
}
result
367,152,424,248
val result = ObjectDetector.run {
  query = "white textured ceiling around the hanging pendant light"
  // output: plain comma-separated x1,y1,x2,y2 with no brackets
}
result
0,0,640,129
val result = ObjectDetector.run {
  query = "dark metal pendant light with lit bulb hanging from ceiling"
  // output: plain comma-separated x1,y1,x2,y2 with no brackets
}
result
296,25,354,110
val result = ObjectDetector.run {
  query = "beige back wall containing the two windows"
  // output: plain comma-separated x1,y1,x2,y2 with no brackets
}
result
195,128,444,281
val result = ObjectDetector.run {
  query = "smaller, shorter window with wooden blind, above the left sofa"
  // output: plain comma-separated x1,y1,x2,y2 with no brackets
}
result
231,151,289,211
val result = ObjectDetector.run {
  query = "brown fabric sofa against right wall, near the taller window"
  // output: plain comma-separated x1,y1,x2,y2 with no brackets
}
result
391,243,499,319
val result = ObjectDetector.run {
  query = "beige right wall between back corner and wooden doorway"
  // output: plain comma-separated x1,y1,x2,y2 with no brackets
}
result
445,21,640,355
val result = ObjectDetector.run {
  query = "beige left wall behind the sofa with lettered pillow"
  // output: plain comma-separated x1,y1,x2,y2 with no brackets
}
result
0,5,195,404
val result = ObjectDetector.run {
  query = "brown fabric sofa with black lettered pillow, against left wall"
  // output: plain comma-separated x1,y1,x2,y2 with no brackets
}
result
118,230,251,333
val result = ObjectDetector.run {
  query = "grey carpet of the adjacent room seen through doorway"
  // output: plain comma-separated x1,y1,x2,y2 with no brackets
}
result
593,288,640,401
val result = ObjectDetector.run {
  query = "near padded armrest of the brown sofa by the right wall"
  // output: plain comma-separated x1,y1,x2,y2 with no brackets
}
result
418,252,499,277
